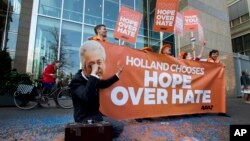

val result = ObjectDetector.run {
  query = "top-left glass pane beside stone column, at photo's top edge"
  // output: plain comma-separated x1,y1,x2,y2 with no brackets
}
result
39,0,62,18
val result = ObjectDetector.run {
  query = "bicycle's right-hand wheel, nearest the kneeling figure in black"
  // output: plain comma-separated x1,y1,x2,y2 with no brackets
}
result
57,88,73,109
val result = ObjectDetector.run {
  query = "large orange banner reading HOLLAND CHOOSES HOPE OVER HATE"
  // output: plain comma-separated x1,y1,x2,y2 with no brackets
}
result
100,43,226,119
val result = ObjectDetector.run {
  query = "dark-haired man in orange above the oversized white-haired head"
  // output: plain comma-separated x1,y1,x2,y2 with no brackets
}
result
88,24,107,42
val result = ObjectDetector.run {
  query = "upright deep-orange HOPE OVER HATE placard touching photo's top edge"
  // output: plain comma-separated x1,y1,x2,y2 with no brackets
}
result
154,0,179,33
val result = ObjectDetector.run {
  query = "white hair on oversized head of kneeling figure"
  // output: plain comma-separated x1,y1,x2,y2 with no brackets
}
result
79,40,106,66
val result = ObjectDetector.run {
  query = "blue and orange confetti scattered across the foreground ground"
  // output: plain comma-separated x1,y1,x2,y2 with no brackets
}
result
0,115,231,141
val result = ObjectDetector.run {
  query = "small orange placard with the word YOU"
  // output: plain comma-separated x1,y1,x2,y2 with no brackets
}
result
183,9,199,32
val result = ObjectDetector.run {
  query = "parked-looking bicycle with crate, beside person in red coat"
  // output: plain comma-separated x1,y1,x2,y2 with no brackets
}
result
13,80,73,110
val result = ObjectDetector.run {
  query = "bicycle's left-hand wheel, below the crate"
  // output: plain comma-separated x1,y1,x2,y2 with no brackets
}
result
13,91,38,110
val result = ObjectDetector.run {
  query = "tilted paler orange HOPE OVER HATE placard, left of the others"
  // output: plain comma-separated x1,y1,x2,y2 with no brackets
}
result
114,6,142,43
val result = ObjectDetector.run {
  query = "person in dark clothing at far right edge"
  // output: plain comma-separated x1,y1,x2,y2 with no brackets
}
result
240,71,250,104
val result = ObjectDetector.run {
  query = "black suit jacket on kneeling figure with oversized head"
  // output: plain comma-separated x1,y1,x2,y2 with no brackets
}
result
69,70,119,122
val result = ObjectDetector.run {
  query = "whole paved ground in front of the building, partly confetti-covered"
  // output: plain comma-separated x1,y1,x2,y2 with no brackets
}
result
0,96,250,141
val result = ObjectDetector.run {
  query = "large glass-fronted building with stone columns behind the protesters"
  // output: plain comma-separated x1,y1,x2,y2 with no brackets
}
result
0,0,237,96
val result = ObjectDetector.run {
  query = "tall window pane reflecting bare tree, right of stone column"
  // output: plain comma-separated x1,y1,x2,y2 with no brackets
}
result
33,17,59,78
